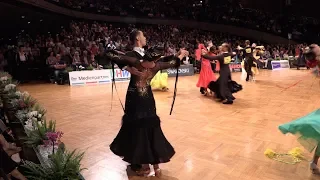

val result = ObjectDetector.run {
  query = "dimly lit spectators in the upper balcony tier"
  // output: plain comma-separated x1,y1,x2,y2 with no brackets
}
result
48,0,319,39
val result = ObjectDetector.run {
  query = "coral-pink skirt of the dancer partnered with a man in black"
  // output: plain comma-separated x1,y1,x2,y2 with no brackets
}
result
197,60,217,88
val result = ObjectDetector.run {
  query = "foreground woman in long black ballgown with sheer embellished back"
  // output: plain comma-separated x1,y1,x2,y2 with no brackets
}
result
110,46,188,176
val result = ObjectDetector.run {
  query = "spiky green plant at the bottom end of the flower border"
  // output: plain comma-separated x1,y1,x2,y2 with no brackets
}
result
23,148,85,180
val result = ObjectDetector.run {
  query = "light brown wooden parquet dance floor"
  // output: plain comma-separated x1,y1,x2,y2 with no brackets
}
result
21,70,320,180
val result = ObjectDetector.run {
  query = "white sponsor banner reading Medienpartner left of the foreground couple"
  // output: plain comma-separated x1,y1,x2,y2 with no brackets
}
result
69,70,111,86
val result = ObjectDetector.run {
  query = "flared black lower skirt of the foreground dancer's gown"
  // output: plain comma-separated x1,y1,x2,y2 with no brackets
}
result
110,115,175,164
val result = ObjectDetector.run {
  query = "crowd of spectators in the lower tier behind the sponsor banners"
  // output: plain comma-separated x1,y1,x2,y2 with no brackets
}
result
0,22,310,82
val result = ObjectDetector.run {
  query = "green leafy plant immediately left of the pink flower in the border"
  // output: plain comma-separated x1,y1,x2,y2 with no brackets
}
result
24,120,56,147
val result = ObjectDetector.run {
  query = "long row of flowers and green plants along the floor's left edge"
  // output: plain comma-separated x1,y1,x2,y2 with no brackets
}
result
0,72,84,180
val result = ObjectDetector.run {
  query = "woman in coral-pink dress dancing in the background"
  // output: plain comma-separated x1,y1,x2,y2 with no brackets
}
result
196,44,217,96
